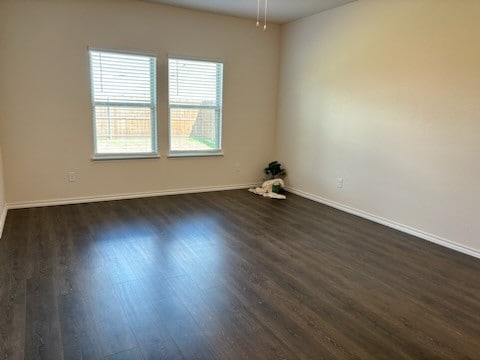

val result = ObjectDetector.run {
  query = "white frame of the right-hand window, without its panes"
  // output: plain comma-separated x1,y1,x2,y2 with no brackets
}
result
167,54,225,158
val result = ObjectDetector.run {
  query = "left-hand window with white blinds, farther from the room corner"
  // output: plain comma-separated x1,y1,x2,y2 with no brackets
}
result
90,50,157,158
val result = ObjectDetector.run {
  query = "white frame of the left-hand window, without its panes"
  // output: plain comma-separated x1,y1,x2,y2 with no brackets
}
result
88,47,160,160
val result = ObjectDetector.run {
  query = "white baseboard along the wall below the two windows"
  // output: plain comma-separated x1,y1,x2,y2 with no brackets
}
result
6,183,258,209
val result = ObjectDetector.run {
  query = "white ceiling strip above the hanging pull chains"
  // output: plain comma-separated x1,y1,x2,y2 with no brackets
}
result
148,0,356,24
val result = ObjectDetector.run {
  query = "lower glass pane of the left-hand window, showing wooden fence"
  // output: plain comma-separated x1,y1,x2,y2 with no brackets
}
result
95,106,152,154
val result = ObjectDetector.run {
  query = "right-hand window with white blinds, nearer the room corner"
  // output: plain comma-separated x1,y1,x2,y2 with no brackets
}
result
168,58,223,156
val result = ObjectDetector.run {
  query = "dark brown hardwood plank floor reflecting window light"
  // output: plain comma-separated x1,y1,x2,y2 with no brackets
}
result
0,191,480,360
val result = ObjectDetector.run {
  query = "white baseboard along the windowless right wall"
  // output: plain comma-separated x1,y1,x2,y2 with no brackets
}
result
286,187,480,259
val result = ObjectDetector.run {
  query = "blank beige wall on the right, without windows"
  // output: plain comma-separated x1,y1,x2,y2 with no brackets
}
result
276,0,480,251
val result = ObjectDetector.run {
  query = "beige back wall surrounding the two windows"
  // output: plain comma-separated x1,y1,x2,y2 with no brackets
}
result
0,0,280,203
